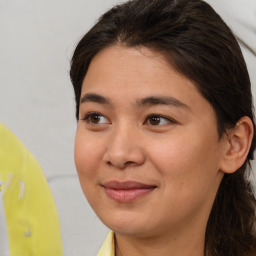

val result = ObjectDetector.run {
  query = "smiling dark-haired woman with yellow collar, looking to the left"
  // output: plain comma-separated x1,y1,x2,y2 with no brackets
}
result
70,0,256,256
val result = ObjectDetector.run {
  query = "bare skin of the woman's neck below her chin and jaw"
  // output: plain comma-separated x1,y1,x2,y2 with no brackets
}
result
115,207,209,256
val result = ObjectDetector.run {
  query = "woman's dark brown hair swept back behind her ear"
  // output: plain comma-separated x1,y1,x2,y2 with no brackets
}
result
70,0,256,256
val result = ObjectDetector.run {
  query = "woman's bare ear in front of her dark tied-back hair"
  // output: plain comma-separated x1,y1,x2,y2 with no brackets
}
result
220,116,254,173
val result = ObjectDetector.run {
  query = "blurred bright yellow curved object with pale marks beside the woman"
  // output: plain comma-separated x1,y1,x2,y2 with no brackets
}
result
0,124,62,256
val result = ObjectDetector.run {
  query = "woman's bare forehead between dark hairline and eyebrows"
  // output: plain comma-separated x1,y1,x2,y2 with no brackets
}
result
82,45,210,109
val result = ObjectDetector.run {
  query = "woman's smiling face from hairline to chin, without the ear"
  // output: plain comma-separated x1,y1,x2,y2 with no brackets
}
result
75,46,226,236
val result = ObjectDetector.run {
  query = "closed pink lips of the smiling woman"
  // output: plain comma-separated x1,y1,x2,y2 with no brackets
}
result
102,181,157,203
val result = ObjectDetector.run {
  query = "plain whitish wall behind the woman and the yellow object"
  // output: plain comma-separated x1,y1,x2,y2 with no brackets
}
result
0,0,256,256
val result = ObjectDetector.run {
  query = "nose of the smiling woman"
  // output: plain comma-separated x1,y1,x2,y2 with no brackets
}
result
103,125,145,169
